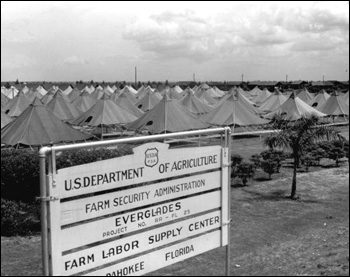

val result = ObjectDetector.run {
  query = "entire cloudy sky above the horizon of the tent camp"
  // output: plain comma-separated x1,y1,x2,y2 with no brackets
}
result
1,1,349,82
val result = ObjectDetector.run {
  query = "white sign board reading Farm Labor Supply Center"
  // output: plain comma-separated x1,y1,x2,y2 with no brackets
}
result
61,211,221,275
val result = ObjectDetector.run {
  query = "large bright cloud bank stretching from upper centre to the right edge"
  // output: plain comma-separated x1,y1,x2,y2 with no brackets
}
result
124,2,349,62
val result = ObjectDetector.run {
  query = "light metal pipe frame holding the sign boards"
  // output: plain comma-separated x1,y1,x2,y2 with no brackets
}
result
39,127,231,276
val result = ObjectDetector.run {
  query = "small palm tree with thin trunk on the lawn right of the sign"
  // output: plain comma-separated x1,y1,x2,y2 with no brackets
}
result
264,115,343,200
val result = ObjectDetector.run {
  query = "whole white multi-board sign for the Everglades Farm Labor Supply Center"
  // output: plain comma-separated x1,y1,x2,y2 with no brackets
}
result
41,129,229,276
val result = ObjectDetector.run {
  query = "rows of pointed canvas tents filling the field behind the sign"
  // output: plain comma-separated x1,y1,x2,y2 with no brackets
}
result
1,83,349,149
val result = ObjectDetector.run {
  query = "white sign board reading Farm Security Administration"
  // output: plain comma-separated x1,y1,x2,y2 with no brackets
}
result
61,171,221,226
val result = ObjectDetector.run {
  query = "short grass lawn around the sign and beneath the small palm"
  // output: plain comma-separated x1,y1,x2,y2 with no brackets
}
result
1,127,349,276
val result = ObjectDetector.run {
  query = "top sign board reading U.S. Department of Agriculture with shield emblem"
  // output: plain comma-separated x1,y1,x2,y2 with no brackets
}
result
56,143,221,199
